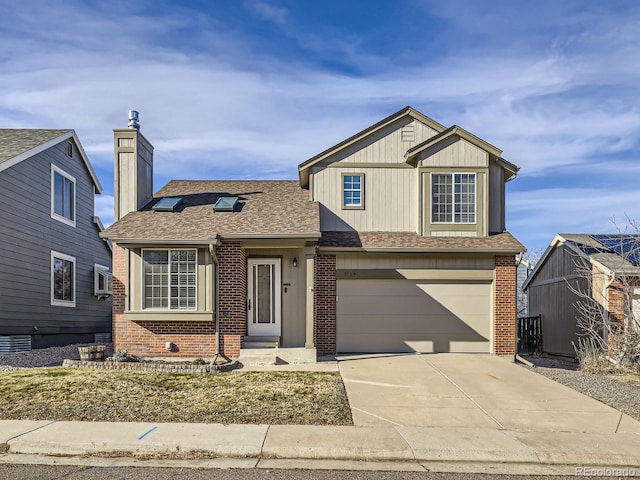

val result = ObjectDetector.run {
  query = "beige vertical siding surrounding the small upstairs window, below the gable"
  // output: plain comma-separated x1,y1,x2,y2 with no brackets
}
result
313,167,418,232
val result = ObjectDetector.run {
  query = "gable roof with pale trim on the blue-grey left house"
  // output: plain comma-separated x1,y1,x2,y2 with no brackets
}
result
0,128,102,193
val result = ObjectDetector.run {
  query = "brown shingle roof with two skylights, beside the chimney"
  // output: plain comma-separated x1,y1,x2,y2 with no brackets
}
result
100,180,320,244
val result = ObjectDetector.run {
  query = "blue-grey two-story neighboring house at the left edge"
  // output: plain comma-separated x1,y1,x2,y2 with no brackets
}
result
0,129,111,353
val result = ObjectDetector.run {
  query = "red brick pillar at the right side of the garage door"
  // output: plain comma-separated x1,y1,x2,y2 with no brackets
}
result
494,256,517,355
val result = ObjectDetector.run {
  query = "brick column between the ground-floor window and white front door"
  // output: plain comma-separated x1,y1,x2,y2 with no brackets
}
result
216,242,247,357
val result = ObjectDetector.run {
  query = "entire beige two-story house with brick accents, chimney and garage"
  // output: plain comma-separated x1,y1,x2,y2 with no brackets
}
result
102,107,524,361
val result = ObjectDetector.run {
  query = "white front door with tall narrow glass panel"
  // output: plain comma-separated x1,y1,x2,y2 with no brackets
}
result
247,258,282,336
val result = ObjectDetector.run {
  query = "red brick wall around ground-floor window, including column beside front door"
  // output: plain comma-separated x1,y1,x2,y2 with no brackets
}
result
113,243,247,358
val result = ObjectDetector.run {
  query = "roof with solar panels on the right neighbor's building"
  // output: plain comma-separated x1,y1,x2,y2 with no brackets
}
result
522,233,640,289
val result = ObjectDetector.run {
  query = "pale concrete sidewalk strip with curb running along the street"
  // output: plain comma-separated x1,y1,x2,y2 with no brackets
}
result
0,420,640,475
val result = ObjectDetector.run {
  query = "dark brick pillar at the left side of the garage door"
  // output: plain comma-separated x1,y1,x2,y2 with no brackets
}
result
313,255,337,355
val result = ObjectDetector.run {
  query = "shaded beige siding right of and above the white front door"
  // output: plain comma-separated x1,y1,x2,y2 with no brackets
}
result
247,248,306,348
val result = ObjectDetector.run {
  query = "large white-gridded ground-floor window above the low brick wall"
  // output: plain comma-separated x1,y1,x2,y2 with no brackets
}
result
143,250,197,310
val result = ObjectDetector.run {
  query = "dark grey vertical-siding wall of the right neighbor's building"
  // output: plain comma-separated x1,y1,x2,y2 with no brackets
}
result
527,245,589,355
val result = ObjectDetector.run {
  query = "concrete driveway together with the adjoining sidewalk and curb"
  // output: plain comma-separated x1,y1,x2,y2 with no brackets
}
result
0,355,640,476
